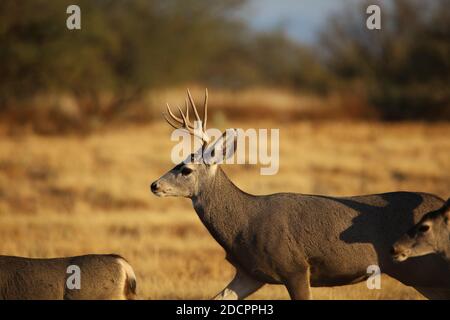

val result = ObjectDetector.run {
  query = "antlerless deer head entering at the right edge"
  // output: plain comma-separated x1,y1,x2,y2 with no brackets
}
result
391,198,450,264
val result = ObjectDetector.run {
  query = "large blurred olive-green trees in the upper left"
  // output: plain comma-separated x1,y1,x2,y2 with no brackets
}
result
0,0,256,112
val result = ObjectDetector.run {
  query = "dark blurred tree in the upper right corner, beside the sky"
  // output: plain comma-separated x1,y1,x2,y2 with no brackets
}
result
321,0,450,120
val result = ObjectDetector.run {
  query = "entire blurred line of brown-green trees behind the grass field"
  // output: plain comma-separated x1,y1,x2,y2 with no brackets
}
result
0,0,450,132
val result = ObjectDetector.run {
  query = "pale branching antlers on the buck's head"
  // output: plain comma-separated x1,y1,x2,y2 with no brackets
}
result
163,89,210,145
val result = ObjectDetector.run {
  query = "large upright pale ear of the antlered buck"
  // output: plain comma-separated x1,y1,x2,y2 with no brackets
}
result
203,129,238,165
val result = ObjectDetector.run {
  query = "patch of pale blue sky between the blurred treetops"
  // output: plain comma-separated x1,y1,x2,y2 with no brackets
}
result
242,0,361,43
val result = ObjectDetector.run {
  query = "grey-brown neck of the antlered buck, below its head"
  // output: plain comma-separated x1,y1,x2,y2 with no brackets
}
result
192,167,254,251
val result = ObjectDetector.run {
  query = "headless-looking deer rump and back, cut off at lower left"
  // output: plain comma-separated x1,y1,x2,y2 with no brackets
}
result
0,254,136,300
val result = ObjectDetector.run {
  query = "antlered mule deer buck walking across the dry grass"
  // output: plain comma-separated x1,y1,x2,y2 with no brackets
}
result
150,90,450,299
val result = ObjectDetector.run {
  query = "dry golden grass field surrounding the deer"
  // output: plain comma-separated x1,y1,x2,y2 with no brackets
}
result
0,118,450,299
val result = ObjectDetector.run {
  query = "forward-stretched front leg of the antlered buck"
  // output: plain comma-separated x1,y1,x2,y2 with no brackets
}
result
213,270,264,300
